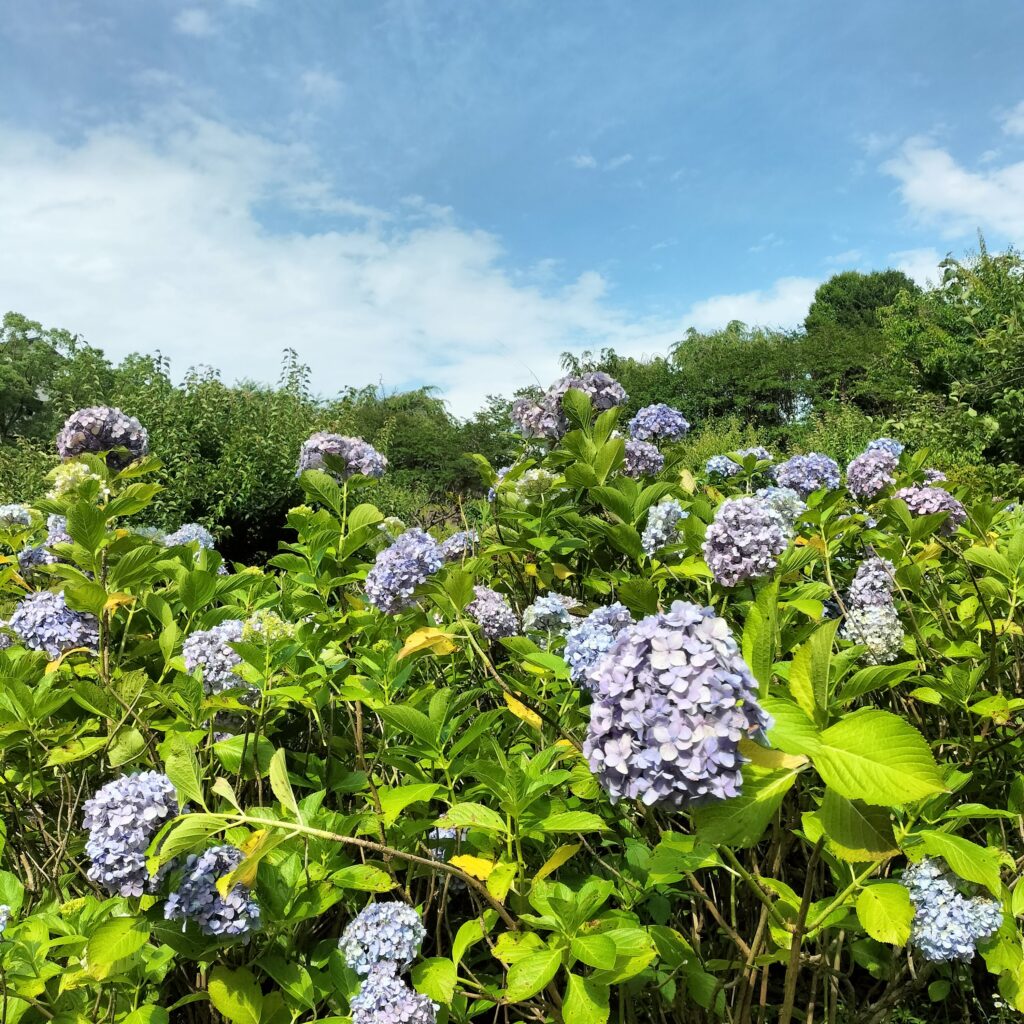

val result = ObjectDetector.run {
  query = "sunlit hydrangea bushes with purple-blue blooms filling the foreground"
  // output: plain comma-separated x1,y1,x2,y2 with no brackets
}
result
0,393,1024,1024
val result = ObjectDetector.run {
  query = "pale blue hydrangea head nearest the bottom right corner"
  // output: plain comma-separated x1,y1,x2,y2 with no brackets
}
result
901,858,1002,962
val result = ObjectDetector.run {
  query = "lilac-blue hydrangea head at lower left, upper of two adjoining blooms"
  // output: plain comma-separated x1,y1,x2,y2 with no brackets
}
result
83,771,178,896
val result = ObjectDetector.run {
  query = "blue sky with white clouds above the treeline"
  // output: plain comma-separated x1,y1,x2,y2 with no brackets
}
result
0,0,1024,413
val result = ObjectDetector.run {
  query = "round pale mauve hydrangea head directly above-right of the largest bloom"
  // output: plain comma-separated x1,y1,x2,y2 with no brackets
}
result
703,498,791,587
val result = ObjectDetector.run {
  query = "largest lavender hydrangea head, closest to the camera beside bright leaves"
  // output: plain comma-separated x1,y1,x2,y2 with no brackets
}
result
584,601,771,807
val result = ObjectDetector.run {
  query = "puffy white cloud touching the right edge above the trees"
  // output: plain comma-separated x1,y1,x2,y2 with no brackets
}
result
882,137,1024,237
